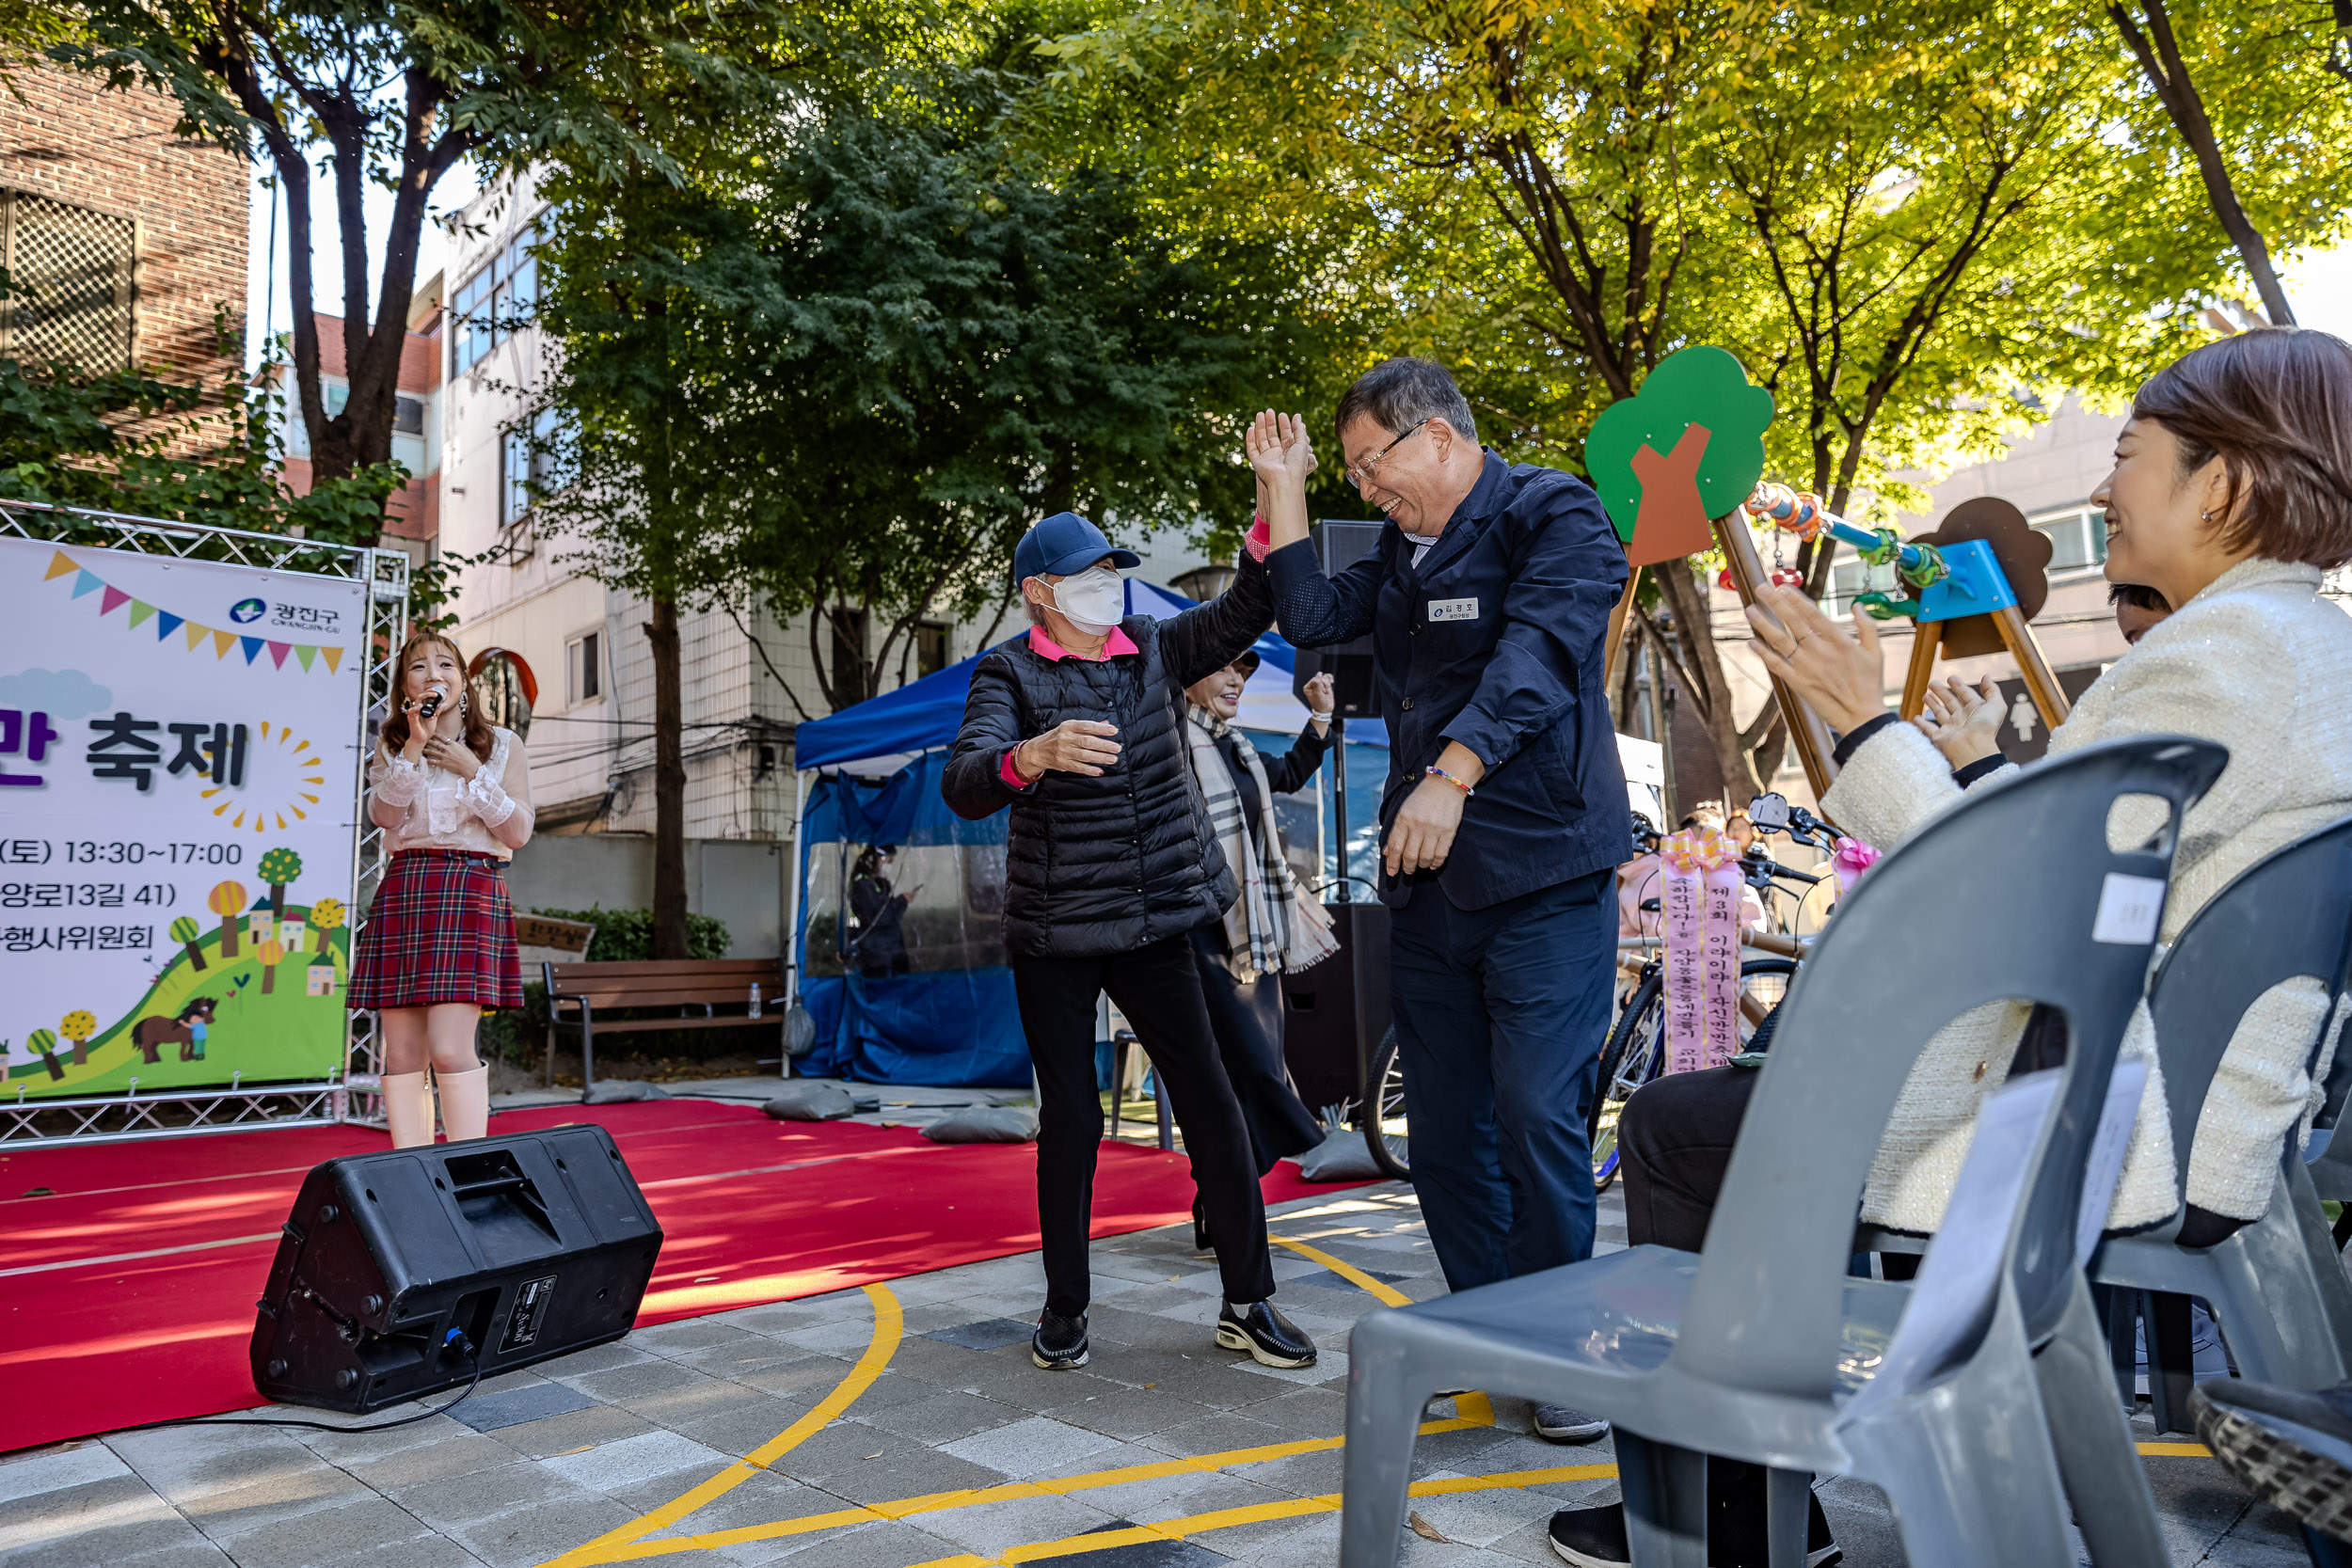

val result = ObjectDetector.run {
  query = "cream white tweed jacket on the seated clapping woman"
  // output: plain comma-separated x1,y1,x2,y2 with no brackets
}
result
1823,560,2352,1232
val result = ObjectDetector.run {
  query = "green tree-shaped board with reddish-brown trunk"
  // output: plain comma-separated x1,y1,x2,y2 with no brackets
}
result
1585,345,1772,566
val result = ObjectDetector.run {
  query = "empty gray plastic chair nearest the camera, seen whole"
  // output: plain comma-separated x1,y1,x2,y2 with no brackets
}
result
1341,736,2228,1568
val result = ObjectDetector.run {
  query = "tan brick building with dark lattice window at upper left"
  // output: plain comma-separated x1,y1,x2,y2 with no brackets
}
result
0,63,247,381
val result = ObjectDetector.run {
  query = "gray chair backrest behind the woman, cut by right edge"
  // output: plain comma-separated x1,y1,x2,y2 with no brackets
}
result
2148,816,2352,1194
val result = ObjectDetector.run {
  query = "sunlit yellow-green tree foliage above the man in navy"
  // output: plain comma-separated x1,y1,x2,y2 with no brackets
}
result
1047,0,2345,787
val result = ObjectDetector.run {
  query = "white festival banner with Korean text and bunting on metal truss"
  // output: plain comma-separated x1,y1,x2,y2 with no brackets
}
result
0,538,367,1101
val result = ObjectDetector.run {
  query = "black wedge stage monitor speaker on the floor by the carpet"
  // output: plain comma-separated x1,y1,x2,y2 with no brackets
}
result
252,1124,661,1413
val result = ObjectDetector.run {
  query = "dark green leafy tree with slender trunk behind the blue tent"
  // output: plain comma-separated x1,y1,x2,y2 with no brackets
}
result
534,35,1345,957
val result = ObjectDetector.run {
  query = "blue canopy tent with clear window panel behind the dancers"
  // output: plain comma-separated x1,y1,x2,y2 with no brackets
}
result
790,578,1388,1084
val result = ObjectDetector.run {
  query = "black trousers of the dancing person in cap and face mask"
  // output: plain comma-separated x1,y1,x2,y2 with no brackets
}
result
1011,936,1275,1317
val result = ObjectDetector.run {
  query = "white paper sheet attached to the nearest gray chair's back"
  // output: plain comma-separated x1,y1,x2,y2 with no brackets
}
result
1839,1060,2148,1425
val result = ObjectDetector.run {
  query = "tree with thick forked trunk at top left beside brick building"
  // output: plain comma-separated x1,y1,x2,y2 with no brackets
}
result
50,0,804,526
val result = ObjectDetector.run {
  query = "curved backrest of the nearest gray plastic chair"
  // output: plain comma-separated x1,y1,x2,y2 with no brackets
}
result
1673,736,2230,1399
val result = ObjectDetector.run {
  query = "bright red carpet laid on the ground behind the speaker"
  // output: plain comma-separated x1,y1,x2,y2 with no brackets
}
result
0,1101,1348,1453
